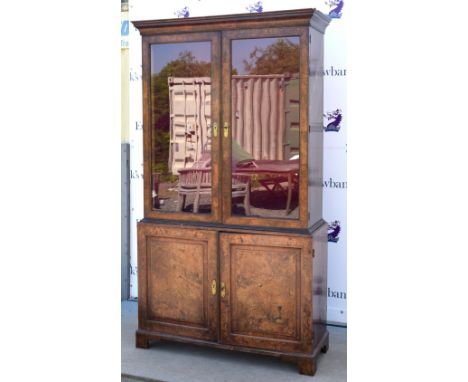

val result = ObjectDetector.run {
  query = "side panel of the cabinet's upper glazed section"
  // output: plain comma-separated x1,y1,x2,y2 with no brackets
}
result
308,28,323,226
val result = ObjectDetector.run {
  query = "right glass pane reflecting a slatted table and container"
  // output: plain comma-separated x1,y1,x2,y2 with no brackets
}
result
231,37,299,219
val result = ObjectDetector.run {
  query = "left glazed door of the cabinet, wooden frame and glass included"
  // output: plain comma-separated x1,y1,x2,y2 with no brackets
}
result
142,32,221,221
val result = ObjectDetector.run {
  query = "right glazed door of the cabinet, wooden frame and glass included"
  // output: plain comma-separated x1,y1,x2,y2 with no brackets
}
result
222,27,309,228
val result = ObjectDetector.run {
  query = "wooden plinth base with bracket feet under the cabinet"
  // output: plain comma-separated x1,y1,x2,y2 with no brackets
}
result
135,329,329,376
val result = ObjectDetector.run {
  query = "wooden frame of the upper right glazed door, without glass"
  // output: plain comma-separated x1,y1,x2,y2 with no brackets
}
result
220,27,309,228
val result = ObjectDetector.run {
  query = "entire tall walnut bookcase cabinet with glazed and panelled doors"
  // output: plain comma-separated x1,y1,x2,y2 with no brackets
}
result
133,9,329,375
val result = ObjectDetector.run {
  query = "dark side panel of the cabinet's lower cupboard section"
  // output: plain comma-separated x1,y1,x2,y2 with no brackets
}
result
312,223,328,347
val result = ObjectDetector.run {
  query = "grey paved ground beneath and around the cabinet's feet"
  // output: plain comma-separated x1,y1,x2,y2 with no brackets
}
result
121,301,346,382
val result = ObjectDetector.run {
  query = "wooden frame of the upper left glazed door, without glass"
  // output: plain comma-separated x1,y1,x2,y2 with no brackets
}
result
142,32,222,222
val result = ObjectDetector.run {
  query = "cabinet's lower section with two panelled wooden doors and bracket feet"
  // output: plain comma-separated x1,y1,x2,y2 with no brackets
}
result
136,223,328,375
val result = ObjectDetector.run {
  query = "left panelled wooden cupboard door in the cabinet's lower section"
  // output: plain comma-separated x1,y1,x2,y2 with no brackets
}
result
138,223,218,340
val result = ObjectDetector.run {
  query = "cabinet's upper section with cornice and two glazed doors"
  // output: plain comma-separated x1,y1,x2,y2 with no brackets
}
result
134,9,329,228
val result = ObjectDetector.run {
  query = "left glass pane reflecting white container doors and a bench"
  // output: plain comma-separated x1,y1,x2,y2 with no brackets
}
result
151,41,212,213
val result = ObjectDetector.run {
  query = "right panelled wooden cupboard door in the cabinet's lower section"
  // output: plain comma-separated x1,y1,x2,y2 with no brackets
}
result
220,233,312,352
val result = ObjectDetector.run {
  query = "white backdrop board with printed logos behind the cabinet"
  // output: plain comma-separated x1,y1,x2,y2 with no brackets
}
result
128,0,347,323
